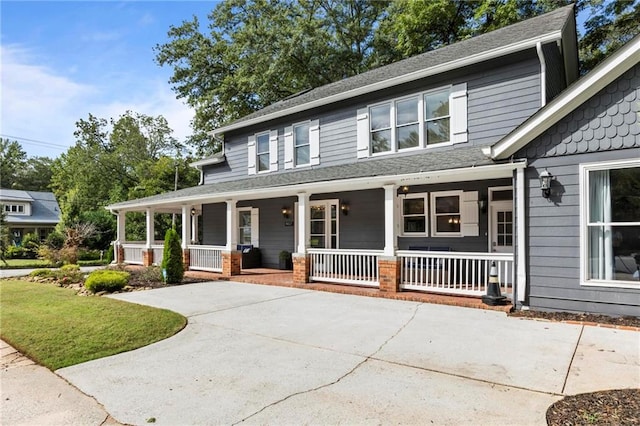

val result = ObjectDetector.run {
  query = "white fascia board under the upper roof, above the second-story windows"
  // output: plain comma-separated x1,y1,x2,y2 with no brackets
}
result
209,31,562,137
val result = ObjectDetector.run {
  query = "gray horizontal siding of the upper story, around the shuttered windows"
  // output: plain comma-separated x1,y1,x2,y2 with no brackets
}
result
204,50,541,183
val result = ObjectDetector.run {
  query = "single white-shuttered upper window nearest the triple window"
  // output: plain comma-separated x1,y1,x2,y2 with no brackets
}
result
284,120,320,169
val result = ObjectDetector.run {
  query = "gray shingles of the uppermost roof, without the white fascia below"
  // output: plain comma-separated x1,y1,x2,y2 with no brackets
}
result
214,5,573,134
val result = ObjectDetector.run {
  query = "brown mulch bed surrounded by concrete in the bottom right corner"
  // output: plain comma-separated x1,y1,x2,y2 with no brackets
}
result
547,389,640,426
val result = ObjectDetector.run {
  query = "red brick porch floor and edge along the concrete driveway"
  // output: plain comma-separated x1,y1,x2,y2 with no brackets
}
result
185,268,512,312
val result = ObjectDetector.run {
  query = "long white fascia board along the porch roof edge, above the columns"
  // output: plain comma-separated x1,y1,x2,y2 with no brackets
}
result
105,161,527,212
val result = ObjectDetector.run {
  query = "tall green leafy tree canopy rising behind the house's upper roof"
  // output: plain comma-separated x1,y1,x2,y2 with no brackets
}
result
155,0,640,154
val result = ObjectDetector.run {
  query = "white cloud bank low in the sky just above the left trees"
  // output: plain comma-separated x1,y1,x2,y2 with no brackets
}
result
0,45,193,157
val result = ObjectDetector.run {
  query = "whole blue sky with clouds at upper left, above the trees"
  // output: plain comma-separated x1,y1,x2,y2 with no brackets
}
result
0,0,215,158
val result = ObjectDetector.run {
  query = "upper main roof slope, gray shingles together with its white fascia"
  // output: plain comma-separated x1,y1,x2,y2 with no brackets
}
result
211,5,575,136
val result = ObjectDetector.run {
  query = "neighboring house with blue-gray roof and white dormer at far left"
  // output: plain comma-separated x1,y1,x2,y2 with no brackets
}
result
0,188,60,245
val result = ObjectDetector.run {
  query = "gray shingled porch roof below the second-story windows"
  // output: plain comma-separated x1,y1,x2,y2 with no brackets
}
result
108,146,495,209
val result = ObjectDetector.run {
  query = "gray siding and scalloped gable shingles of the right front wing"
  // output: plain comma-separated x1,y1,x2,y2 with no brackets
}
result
518,65,640,316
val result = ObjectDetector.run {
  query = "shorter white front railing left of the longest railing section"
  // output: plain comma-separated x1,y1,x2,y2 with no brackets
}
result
308,249,383,287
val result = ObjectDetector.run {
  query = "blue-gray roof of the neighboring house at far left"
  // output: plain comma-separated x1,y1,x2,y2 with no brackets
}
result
0,188,60,225
